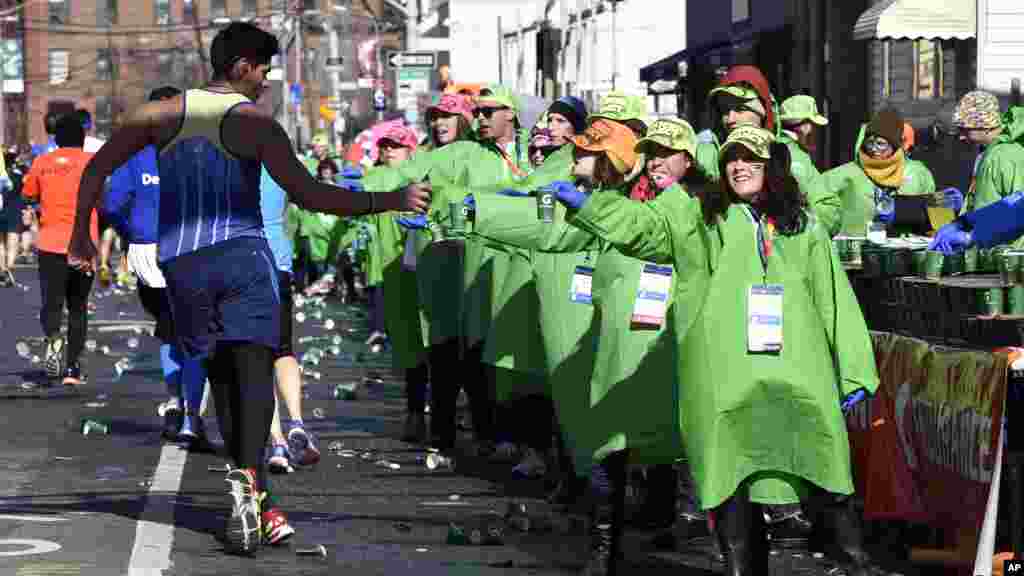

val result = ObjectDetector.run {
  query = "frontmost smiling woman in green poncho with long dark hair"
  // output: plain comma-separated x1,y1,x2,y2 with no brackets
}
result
558,126,878,574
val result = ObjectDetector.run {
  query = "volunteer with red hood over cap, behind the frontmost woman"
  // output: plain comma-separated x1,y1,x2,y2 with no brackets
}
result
696,66,842,236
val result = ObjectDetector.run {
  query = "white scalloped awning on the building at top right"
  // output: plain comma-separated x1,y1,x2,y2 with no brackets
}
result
853,0,978,40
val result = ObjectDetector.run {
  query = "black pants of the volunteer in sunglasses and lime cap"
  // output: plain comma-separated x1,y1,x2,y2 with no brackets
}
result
430,338,495,450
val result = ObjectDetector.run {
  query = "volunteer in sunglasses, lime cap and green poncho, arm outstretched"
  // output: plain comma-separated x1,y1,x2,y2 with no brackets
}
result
362,86,543,451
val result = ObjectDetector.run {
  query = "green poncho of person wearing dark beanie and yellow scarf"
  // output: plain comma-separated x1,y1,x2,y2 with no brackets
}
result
818,126,935,236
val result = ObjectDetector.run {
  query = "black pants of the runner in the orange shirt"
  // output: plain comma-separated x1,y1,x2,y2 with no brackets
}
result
39,251,92,364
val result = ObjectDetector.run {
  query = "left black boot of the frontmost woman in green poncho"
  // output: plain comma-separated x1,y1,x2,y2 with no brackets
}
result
715,487,768,576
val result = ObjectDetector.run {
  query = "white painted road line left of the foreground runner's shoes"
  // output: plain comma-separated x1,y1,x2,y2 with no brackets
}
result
127,445,188,576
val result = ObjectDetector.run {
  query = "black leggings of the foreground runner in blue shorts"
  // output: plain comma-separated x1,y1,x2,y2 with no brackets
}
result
207,342,273,490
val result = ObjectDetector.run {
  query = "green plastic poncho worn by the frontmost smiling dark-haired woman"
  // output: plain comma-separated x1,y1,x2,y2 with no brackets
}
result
569,193,879,508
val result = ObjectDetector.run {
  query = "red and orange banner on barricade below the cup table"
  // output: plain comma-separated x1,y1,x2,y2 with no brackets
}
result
847,332,1009,533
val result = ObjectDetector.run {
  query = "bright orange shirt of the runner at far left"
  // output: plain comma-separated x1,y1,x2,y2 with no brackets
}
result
22,148,99,254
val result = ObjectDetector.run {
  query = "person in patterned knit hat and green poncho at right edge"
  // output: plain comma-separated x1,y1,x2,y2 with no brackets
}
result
953,90,1024,237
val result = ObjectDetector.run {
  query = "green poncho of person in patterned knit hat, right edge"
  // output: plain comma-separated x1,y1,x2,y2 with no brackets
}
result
967,107,1024,213
